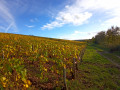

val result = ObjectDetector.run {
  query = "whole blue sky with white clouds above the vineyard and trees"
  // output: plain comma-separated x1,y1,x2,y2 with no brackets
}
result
0,0,120,40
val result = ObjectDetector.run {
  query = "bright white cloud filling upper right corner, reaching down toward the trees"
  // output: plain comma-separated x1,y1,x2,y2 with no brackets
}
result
74,0,120,28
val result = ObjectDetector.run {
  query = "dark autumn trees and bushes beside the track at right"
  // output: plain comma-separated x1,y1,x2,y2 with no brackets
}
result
92,26,120,52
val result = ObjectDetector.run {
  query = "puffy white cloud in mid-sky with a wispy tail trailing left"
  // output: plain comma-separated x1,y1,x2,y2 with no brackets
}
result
41,0,92,29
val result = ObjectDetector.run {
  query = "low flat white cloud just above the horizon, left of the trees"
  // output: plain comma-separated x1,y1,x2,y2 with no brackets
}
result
60,30,98,40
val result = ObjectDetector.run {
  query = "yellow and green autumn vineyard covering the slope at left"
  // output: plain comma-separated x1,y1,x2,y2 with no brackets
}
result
0,33,86,90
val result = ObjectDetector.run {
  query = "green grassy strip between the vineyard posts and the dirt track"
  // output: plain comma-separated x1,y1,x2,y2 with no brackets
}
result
68,46,120,90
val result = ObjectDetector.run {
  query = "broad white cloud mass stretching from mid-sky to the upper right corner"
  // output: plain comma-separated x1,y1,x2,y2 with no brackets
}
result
41,0,120,29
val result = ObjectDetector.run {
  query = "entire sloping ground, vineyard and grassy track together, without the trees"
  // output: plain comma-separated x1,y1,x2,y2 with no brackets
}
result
0,33,120,90
